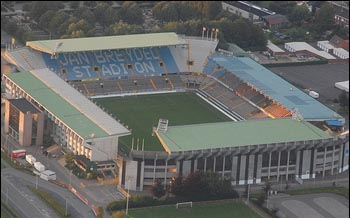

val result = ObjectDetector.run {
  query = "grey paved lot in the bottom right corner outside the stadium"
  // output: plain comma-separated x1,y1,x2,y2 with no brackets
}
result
269,193,349,218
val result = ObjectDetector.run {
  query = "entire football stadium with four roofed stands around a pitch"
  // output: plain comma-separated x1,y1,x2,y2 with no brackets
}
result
2,32,349,190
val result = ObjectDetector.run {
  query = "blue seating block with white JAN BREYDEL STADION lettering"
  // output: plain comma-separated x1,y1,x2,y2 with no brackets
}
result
42,47,179,81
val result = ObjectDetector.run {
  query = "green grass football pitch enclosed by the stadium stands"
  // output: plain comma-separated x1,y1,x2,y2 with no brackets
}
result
94,92,230,151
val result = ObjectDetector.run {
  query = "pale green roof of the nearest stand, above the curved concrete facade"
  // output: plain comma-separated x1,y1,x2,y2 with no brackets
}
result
157,119,332,153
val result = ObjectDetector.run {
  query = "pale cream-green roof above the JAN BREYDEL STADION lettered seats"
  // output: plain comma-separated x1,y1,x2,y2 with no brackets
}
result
26,33,187,54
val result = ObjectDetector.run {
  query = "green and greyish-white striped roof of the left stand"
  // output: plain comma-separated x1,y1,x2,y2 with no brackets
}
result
6,69,130,139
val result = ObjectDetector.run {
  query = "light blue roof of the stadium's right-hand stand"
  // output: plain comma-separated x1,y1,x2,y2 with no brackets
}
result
209,56,344,120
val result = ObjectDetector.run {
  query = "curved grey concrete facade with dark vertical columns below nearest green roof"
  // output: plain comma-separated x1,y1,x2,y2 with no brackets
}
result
121,136,349,190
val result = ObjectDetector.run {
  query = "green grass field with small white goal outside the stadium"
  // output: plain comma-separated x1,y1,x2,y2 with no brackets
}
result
129,201,261,218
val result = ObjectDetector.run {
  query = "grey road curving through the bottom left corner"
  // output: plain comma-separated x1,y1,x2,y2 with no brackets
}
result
1,158,95,218
